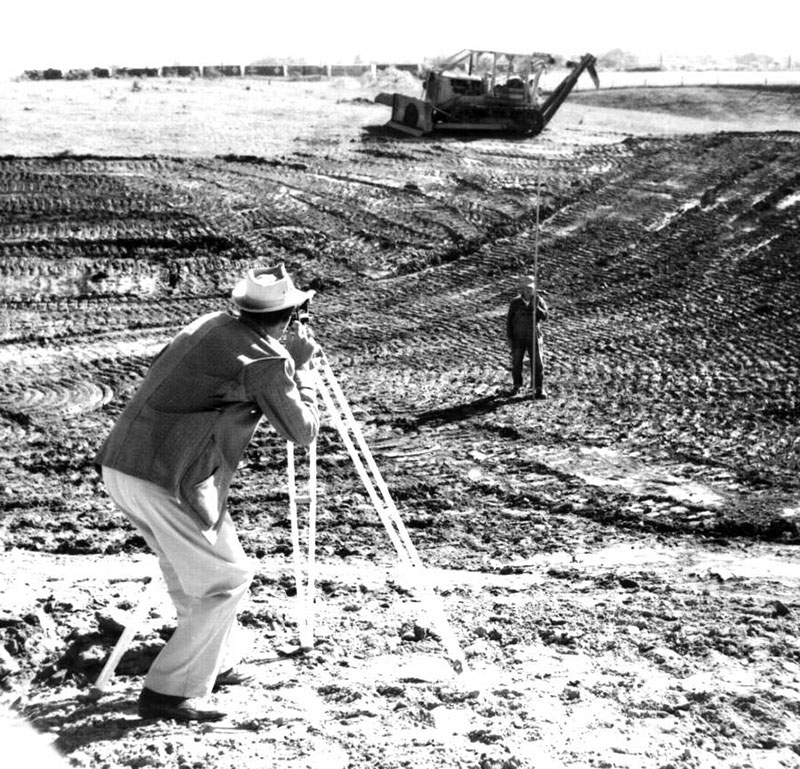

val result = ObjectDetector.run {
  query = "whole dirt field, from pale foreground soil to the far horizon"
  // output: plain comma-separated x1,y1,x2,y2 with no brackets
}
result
0,73,800,769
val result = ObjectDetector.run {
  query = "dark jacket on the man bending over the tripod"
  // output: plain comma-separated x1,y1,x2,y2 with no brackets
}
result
95,312,319,531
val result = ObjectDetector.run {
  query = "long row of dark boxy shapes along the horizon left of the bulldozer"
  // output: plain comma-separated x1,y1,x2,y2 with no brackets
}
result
18,63,423,80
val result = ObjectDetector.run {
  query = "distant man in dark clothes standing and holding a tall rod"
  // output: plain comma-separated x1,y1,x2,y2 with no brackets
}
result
506,275,547,398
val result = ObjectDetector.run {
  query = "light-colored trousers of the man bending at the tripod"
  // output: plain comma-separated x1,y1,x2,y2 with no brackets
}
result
103,467,254,698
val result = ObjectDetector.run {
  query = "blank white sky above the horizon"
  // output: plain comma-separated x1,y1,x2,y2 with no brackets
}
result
0,0,800,75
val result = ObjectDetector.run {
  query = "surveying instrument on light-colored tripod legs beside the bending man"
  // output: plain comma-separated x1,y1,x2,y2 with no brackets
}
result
89,300,466,699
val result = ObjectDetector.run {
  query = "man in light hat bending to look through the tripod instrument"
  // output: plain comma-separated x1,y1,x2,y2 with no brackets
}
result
95,264,319,721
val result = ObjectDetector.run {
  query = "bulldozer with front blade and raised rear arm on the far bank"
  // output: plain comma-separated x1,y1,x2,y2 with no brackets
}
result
375,49,600,136
